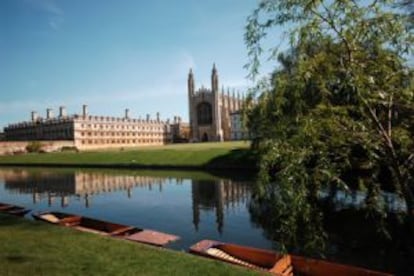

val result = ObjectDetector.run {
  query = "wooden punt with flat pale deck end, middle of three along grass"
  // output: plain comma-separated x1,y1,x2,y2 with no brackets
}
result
32,212,179,246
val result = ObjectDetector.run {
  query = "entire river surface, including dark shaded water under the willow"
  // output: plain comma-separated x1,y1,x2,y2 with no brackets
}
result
0,168,414,275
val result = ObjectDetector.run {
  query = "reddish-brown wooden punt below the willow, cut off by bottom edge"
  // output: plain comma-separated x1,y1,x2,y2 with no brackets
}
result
190,240,391,276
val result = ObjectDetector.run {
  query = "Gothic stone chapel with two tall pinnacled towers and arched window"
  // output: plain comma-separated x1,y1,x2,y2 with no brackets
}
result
188,65,243,141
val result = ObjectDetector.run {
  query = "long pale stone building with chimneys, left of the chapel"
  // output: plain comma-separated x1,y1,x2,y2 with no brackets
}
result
4,105,171,149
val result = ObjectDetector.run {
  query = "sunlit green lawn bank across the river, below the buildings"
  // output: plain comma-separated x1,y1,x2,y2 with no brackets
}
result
0,141,257,171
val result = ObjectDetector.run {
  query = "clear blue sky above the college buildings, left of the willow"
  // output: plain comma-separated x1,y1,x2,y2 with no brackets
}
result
0,0,278,129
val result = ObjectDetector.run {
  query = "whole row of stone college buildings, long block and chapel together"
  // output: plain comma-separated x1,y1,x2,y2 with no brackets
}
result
0,65,248,150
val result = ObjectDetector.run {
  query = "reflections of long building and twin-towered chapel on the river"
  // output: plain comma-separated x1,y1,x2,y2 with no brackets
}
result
0,170,250,233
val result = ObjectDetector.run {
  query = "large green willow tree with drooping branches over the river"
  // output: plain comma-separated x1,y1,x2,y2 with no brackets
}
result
245,0,414,249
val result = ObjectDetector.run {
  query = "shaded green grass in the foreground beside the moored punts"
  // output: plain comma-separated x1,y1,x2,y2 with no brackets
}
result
0,214,256,275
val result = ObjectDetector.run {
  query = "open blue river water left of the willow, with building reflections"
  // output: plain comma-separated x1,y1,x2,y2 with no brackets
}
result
0,168,272,250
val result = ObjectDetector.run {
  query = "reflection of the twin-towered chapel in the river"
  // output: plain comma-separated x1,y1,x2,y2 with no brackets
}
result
192,180,250,233
